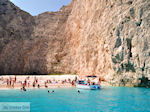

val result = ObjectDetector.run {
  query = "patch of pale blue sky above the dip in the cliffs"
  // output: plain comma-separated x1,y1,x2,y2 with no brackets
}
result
10,0,71,16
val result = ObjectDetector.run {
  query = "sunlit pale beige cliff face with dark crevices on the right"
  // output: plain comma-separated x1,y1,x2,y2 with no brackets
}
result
66,0,150,86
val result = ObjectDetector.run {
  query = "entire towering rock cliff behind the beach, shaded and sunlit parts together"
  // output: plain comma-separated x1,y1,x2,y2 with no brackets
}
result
0,0,150,86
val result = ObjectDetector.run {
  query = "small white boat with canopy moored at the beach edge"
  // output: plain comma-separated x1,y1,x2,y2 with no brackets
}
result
76,80,101,90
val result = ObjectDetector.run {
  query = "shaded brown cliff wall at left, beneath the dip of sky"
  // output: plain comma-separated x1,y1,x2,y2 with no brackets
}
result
0,0,71,74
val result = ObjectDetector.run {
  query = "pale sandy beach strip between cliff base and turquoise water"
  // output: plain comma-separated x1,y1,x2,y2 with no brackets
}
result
0,74,110,90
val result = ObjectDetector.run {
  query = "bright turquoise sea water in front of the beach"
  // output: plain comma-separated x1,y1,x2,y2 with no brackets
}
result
0,87,150,112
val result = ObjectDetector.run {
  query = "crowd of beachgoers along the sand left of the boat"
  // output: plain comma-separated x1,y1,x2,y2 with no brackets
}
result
0,76,77,90
